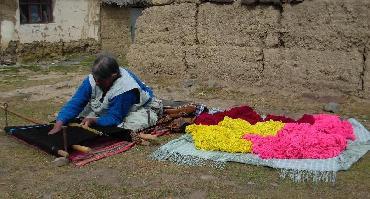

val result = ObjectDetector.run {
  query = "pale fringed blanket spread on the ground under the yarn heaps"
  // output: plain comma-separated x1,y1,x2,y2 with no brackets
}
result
151,118,370,182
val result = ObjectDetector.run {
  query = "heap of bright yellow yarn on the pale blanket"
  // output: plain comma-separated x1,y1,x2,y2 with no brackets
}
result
186,117,284,153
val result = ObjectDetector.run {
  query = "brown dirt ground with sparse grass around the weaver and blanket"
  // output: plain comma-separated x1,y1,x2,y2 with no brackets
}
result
0,56,370,198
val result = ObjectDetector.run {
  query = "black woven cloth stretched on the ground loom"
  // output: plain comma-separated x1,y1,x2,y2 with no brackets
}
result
4,124,132,155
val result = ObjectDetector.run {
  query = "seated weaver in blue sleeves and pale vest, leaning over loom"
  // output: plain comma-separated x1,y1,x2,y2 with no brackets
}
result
49,55,163,134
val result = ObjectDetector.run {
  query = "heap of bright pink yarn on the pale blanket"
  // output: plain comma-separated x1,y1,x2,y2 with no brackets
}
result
243,114,355,159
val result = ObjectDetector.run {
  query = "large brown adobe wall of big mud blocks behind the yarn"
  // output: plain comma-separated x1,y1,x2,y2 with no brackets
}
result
127,0,370,98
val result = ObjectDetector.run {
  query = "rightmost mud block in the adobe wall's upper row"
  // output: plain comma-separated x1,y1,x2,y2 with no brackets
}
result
281,0,370,51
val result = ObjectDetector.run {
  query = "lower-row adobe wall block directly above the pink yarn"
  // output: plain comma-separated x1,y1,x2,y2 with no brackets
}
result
263,48,363,94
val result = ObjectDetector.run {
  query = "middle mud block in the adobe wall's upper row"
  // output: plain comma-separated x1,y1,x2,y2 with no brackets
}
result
198,3,280,48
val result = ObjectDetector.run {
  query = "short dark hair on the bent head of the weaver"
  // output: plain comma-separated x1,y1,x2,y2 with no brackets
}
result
91,54,120,79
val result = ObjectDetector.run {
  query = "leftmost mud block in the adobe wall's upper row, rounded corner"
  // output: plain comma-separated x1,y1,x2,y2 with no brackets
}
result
135,3,196,45
